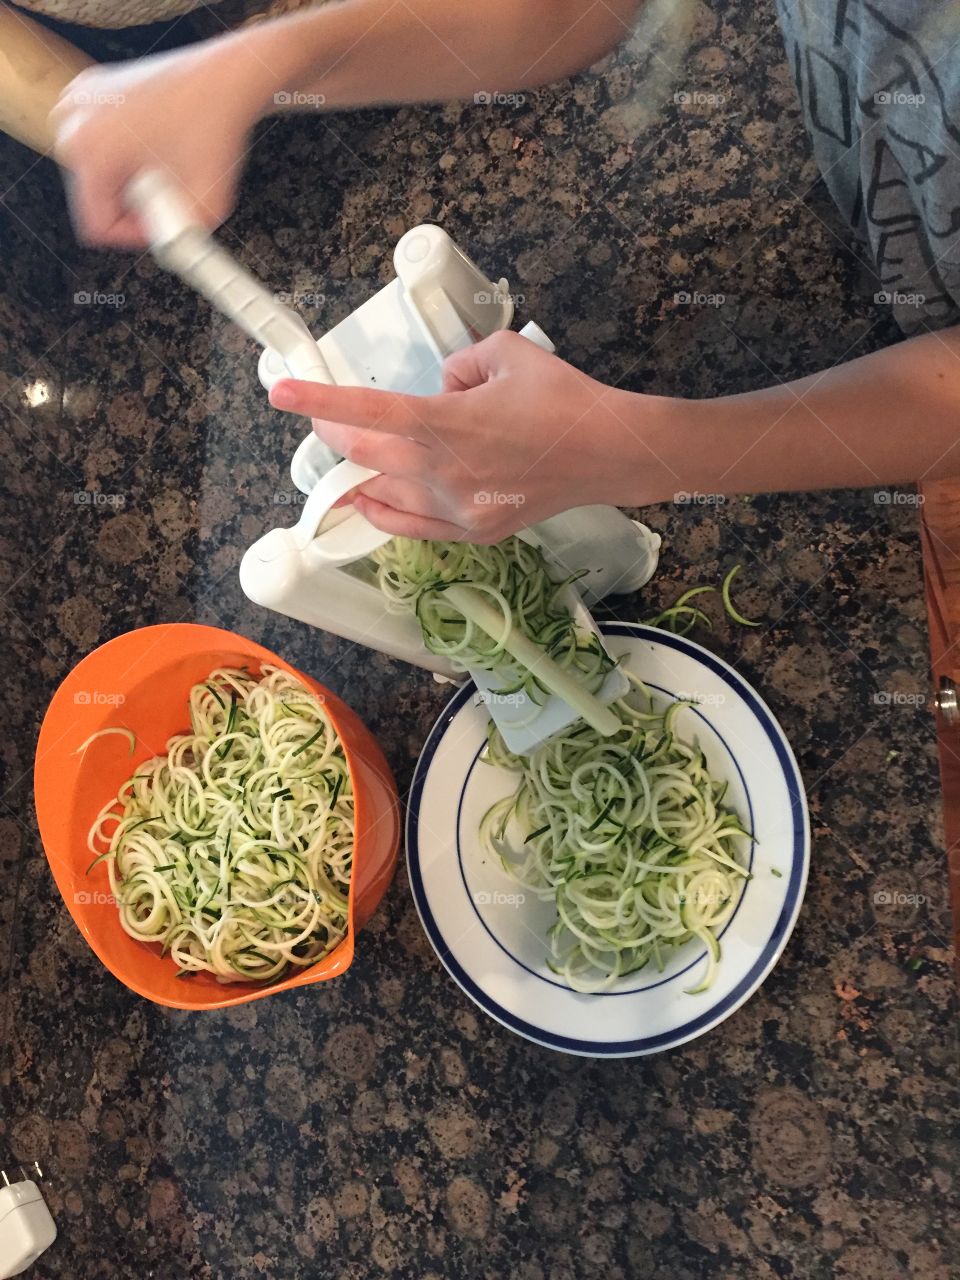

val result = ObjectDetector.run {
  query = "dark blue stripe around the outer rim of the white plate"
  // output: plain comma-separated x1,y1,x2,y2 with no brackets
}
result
407,622,808,1057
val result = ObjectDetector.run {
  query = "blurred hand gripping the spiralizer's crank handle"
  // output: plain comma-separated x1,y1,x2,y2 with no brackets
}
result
50,42,257,248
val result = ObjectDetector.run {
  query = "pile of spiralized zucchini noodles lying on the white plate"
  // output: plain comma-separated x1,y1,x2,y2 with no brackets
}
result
480,677,753,995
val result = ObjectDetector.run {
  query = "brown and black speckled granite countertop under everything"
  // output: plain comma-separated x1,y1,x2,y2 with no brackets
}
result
0,0,959,1280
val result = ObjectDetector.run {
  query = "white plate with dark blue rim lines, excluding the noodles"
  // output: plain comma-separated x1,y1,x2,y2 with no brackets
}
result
407,622,810,1057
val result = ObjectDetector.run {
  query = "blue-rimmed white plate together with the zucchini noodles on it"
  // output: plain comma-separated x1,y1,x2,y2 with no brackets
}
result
407,622,809,1057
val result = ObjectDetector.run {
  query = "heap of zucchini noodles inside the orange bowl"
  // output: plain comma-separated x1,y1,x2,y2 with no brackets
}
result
87,664,353,982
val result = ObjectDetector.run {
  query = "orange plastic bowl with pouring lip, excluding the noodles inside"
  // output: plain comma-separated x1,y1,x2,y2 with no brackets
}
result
33,622,399,1009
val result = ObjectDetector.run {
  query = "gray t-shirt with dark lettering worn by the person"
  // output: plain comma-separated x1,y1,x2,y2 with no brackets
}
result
776,0,960,333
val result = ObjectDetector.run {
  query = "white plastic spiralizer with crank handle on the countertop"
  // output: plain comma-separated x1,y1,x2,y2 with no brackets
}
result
129,173,660,753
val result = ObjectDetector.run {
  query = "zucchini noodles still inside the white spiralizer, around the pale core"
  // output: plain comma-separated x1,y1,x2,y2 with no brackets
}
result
372,536,614,701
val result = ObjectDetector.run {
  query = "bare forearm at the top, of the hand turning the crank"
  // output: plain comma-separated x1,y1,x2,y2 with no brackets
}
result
218,0,639,114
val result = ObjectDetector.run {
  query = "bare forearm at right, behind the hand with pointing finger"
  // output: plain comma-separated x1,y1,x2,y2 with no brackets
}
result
624,329,960,504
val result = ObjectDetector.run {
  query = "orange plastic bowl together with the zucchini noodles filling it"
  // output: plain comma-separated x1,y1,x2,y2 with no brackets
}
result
35,623,399,1009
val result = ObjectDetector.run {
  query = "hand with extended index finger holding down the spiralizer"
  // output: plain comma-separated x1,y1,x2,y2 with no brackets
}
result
270,333,675,543
